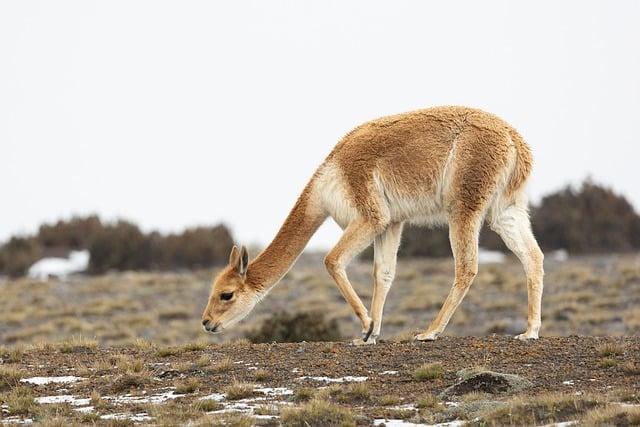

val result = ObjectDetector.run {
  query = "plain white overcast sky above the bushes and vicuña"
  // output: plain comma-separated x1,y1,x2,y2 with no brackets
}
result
0,0,640,251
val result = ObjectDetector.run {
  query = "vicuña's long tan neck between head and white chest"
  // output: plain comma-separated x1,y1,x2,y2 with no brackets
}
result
246,181,326,292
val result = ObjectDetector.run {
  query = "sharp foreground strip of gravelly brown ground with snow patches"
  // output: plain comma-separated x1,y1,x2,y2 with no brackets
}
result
0,336,640,426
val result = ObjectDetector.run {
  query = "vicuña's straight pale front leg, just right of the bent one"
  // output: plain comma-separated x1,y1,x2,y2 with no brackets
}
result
364,223,402,344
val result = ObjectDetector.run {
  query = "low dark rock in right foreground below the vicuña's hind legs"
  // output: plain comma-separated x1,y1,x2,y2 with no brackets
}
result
441,369,533,397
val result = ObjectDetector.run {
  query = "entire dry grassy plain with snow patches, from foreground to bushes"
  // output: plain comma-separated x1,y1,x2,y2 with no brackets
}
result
0,255,640,426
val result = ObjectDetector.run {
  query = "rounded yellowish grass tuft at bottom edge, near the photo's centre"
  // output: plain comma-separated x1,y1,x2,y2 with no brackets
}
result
280,399,355,427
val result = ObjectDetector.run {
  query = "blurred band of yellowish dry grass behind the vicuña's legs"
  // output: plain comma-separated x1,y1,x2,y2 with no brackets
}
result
0,254,640,348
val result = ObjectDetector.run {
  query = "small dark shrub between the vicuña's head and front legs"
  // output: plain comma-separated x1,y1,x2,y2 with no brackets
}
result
246,311,342,343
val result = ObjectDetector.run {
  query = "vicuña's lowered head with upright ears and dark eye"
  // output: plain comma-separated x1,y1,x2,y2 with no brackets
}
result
202,246,259,333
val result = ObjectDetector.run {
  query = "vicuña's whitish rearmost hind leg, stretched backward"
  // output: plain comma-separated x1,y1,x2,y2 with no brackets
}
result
491,202,544,340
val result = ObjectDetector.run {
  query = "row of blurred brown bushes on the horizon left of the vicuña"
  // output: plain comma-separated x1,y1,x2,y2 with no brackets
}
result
0,215,233,276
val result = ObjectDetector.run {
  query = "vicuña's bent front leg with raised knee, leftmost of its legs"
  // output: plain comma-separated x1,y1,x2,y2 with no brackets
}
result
324,220,376,344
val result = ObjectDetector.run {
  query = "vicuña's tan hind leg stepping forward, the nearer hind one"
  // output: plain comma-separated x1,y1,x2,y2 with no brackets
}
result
415,218,480,341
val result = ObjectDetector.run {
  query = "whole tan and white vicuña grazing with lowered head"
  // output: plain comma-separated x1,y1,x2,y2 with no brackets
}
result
202,107,543,344
